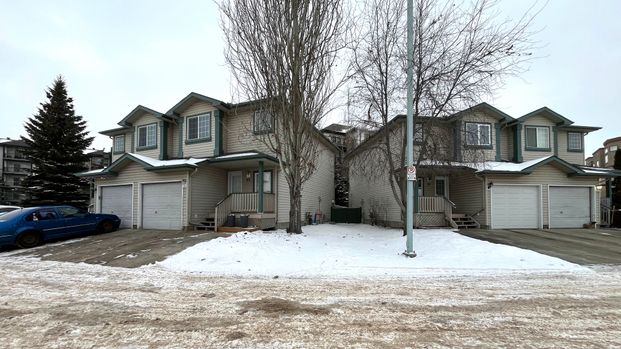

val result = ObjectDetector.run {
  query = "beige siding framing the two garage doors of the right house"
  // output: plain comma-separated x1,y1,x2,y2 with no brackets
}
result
481,164,599,226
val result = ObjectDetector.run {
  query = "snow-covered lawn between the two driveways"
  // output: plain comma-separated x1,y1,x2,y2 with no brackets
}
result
159,224,590,278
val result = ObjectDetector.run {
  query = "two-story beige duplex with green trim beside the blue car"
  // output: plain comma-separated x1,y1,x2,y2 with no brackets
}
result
82,93,338,229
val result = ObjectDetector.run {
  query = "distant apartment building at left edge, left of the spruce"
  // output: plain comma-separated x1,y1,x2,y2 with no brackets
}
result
0,138,32,205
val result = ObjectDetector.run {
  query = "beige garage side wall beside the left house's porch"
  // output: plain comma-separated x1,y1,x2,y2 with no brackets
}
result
189,166,227,222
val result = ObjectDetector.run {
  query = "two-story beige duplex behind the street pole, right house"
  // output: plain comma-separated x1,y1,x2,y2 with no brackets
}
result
347,103,615,229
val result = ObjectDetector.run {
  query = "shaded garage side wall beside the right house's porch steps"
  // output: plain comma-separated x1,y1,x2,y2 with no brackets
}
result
449,172,486,225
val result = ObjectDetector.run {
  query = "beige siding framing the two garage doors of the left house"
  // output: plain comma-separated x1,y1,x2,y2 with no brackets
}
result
95,162,188,228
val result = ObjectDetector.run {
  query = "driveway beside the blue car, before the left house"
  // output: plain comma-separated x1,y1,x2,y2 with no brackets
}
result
5,229,230,268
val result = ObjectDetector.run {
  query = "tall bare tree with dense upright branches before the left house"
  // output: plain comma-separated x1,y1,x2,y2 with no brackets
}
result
220,0,346,233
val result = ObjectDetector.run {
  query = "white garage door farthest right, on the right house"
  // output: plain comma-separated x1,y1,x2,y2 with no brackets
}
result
550,187,591,228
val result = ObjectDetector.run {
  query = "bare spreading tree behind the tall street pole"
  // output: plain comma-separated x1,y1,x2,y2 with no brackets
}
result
350,0,534,228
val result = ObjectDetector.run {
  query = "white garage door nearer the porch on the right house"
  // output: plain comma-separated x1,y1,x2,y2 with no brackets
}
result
492,185,540,229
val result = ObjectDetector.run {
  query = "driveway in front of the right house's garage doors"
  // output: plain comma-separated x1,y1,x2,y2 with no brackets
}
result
459,229,621,265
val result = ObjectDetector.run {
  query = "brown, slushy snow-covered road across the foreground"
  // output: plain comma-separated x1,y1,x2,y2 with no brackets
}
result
0,257,621,348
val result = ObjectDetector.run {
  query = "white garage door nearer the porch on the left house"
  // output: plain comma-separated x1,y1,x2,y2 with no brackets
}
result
142,182,182,230
